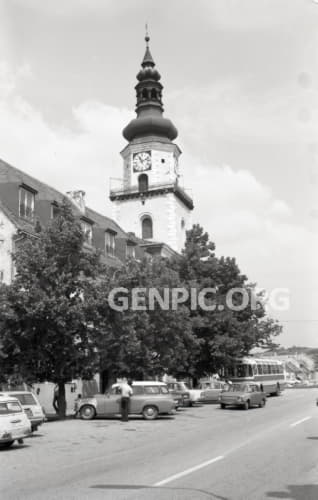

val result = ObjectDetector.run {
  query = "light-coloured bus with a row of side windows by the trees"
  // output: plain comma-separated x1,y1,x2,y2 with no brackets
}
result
225,356,285,396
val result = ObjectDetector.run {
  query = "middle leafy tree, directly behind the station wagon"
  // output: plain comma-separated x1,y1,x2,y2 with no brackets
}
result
91,259,196,379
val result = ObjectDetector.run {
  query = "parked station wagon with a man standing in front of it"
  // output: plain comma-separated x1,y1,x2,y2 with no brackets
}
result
75,381,176,420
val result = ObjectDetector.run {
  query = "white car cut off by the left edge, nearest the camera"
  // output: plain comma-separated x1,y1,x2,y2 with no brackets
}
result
0,396,31,448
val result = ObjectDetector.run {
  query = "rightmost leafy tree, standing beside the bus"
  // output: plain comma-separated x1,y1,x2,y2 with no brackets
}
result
174,225,281,377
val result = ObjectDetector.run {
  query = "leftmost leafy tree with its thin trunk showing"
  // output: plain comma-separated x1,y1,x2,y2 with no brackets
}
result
0,201,101,417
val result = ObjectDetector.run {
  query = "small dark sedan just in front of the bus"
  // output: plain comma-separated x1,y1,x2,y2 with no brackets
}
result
220,383,266,410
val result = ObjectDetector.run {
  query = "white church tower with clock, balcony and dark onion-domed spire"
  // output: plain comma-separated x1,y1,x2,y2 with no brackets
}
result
110,34,193,252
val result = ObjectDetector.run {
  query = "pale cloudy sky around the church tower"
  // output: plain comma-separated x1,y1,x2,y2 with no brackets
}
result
0,0,318,347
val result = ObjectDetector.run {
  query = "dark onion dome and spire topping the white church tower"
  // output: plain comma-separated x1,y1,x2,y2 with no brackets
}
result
123,34,178,142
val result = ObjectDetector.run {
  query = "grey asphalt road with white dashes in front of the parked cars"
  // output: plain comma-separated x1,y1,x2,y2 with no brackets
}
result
0,389,318,500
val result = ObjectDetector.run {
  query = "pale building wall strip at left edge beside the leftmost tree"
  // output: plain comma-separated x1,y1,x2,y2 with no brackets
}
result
0,210,16,285
